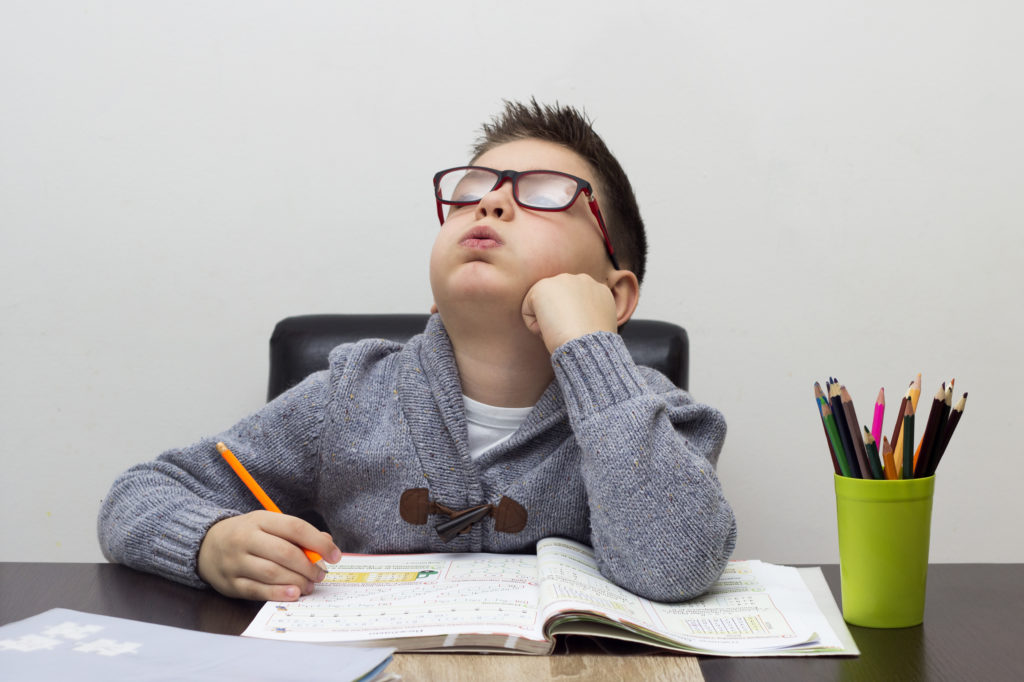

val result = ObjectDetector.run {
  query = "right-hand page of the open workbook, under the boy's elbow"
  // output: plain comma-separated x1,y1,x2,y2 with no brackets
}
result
538,539,843,654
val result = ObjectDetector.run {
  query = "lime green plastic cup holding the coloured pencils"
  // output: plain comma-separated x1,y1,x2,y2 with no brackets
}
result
836,475,935,628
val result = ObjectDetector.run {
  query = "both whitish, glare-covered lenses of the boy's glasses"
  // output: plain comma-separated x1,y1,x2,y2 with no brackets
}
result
438,168,578,210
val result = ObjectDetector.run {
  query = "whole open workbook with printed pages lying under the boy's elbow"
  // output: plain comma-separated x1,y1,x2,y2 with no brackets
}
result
243,538,858,656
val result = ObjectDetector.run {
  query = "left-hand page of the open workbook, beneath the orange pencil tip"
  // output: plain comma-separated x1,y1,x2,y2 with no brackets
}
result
242,554,544,647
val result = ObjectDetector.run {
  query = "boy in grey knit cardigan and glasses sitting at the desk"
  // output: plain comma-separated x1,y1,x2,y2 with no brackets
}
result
99,101,735,601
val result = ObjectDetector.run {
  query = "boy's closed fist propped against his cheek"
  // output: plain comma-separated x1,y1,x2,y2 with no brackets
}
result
522,273,618,353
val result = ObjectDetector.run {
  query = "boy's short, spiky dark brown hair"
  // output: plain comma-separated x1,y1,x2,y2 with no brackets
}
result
473,97,647,282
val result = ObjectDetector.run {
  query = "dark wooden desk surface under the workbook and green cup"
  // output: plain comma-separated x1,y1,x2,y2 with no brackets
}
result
0,563,1024,682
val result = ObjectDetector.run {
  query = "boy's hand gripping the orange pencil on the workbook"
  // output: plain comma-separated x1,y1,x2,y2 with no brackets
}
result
199,510,341,601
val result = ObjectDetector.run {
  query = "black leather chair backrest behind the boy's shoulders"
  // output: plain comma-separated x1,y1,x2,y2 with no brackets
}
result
266,314,689,400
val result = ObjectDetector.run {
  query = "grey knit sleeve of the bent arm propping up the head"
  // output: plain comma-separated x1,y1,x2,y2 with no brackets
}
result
552,332,736,601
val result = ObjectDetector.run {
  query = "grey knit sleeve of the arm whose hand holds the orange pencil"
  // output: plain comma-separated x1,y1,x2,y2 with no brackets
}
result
98,364,329,587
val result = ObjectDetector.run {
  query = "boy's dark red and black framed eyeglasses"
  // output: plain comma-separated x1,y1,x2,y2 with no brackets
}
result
434,166,621,270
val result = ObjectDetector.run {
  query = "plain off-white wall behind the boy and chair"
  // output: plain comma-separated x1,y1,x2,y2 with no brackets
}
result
0,0,1024,562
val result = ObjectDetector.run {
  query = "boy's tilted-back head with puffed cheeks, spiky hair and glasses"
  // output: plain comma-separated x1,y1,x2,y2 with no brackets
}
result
430,101,645,332
